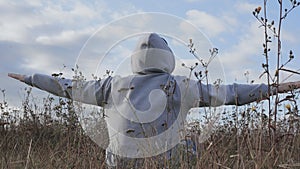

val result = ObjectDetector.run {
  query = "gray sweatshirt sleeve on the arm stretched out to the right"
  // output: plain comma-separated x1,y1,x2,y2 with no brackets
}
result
198,82,268,106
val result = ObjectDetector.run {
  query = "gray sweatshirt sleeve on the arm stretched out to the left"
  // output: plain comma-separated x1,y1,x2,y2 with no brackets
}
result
25,74,112,106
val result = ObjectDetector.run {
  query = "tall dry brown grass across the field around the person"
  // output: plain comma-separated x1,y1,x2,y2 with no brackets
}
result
0,86,300,169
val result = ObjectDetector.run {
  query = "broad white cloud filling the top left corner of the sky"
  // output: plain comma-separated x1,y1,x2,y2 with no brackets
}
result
0,0,107,43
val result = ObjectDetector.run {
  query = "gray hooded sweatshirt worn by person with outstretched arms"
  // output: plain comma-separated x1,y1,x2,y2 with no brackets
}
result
25,33,268,162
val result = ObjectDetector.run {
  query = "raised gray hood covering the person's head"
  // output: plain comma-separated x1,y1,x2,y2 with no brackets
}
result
131,33,175,74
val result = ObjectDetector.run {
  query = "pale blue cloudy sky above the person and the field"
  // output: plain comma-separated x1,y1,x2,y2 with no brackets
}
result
0,0,300,106
